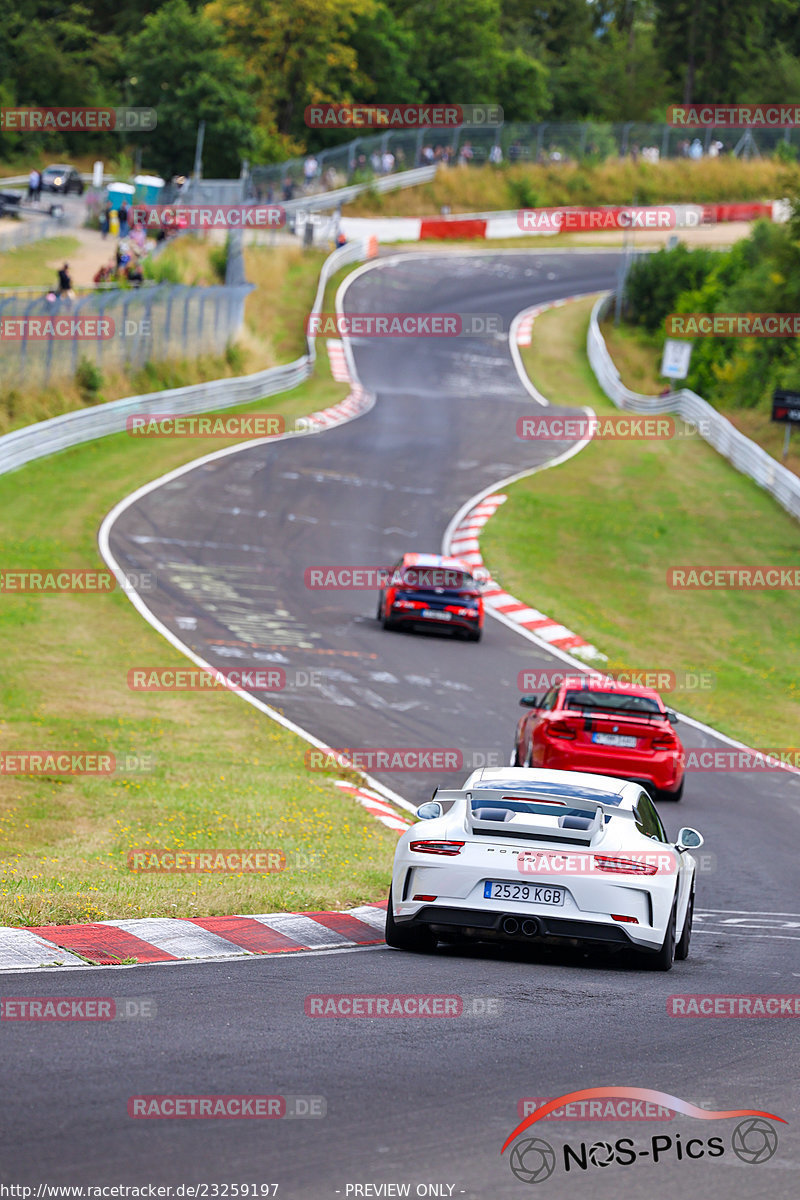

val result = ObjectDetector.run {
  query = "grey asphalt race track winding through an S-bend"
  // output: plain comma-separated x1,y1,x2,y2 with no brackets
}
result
0,252,800,1200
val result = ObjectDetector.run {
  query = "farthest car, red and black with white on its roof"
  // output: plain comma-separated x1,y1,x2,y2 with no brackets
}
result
378,554,483,642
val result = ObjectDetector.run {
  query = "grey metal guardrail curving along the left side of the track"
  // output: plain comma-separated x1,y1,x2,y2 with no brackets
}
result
0,241,369,474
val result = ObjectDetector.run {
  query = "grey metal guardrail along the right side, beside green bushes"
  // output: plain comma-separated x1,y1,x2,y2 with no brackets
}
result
587,293,800,520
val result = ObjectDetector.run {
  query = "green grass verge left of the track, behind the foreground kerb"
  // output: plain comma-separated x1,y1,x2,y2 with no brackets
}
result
0,283,396,925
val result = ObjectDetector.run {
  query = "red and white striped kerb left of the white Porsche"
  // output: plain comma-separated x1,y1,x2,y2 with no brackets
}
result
0,905,386,971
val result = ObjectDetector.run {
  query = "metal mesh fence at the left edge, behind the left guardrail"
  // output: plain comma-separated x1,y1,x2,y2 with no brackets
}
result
0,283,252,388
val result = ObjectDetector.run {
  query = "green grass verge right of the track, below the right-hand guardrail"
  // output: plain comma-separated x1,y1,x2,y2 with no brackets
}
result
481,300,800,748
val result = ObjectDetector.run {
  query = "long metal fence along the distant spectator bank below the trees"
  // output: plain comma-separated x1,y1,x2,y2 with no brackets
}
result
249,121,800,196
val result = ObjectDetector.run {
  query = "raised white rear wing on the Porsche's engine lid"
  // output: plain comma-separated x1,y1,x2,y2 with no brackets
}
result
435,787,633,845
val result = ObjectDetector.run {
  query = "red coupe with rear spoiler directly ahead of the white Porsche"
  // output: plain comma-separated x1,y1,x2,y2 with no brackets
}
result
512,676,685,800
